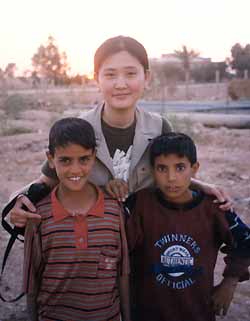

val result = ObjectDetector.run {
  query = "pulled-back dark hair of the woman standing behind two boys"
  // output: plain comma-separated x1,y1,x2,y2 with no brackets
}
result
94,36,149,74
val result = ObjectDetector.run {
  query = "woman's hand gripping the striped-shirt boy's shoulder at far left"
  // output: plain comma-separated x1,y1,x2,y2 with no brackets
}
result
10,195,41,227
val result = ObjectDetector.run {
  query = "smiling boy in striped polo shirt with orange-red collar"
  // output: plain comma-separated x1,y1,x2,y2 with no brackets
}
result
24,118,129,321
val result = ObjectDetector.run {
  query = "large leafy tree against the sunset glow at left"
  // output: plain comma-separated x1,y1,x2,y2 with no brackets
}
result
32,36,69,85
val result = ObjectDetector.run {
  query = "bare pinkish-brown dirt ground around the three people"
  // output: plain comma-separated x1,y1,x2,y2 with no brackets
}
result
0,111,250,321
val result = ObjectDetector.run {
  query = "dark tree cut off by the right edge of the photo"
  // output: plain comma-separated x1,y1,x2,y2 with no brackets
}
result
230,43,250,78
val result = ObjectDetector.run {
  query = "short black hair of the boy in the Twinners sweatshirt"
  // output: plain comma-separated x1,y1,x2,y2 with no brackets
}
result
149,132,197,167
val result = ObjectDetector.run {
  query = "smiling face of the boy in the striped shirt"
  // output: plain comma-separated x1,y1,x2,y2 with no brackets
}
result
47,144,95,192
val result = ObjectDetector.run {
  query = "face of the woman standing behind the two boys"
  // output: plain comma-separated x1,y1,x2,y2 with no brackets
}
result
96,51,149,110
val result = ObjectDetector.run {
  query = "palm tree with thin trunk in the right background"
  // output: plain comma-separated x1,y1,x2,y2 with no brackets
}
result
175,46,199,99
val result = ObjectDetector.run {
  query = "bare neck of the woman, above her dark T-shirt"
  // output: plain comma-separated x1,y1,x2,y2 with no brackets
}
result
102,104,135,128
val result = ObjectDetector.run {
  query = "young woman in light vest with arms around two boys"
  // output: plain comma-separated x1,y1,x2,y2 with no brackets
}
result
8,36,231,227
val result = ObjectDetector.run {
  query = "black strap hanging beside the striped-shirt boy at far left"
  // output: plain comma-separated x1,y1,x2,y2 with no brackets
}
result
0,183,50,302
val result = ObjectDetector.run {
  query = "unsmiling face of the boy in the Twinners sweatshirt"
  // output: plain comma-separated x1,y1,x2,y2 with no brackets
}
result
153,154,199,203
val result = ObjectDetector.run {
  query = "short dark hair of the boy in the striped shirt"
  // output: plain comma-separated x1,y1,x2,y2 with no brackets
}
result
48,117,96,156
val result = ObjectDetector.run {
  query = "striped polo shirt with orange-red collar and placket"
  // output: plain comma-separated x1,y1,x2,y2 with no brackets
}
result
24,186,129,321
